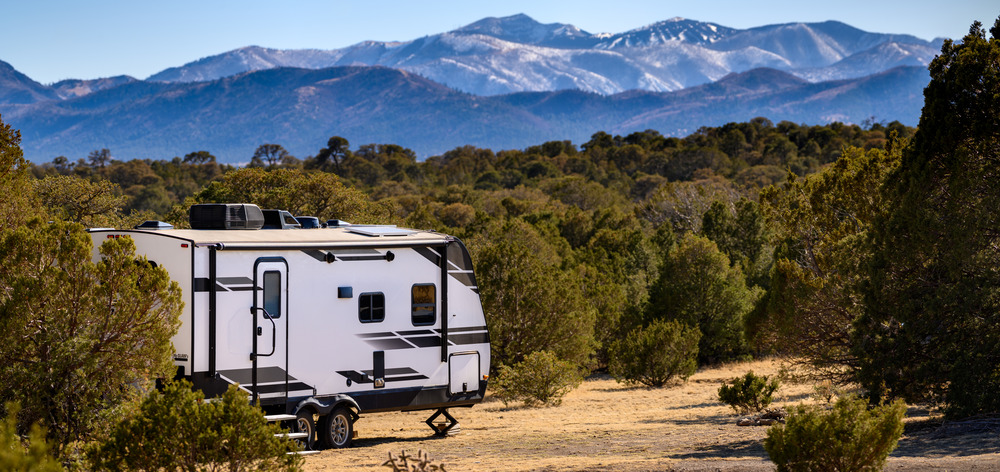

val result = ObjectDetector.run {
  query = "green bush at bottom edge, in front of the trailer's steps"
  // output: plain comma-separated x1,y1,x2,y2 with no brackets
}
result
88,382,302,472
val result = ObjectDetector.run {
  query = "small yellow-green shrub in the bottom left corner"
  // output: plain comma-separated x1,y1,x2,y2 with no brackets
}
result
0,403,63,472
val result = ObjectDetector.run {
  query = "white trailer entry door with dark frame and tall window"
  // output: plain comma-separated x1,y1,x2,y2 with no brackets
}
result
250,257,289,403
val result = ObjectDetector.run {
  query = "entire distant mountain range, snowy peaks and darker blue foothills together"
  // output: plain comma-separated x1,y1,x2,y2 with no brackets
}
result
0,15,940,162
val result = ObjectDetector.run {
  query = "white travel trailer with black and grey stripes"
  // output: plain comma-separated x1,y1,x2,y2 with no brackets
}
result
90,204,490,448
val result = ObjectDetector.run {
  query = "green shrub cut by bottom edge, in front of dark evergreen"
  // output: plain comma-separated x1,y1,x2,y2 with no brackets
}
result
764,396,906,472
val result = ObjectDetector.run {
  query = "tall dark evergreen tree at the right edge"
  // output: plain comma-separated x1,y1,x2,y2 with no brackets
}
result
854,18,1000,416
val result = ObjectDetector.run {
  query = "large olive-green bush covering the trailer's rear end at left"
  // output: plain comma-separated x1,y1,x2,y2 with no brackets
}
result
0,230,184,460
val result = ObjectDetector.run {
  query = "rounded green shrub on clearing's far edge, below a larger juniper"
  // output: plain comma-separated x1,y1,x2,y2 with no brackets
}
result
608,320,701,387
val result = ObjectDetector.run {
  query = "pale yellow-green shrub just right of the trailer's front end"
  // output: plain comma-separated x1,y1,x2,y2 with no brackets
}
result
490,351,583,406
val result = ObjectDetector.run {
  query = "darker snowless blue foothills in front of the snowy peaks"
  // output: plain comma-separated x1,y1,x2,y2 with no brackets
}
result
0,67,927,162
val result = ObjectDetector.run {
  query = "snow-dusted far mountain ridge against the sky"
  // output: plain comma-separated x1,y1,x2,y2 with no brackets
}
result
148,14,939,95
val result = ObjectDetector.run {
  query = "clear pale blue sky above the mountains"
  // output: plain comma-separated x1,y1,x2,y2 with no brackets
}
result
0,0,1000,83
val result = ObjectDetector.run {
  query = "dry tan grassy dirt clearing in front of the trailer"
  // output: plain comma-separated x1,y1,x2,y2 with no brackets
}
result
305,361,1000,472
